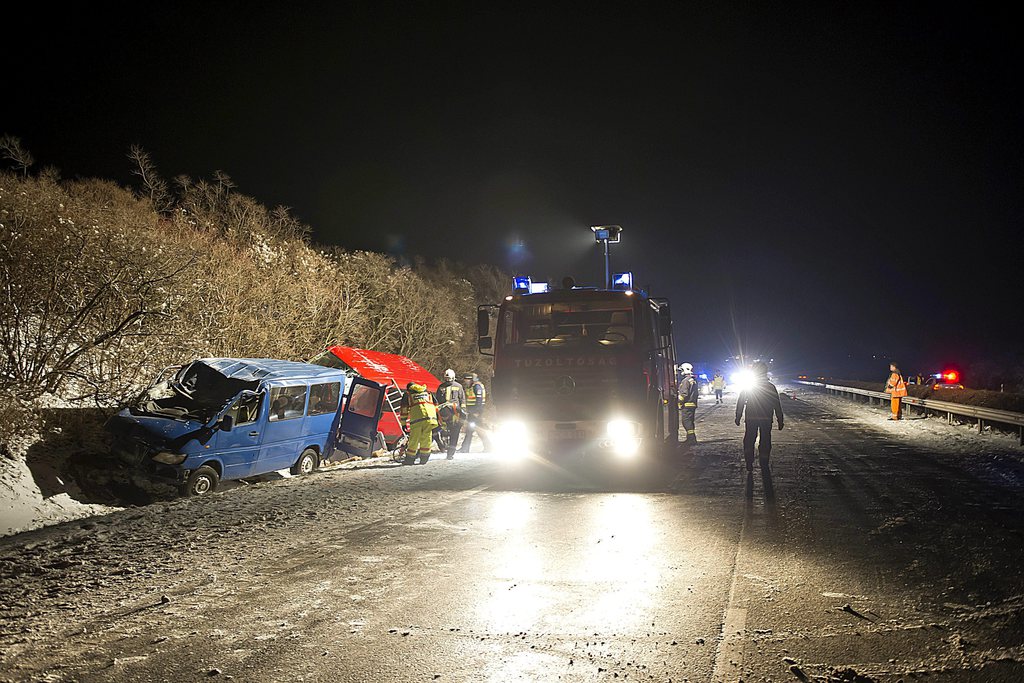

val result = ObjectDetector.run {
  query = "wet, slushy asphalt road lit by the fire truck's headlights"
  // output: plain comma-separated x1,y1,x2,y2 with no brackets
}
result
0,387,1024,682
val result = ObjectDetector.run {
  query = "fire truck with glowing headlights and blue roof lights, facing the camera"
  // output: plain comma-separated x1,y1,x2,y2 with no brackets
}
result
477,278,679,459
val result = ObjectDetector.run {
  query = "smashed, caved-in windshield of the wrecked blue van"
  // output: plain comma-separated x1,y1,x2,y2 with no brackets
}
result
132,360,257,422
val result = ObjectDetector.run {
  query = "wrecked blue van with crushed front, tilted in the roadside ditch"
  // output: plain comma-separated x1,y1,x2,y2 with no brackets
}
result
106,358,384,496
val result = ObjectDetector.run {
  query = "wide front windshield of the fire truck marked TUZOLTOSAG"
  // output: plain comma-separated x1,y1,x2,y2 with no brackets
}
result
502,299,634,347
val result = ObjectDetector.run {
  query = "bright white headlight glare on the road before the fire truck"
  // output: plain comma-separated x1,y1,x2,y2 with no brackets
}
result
476,493,666,681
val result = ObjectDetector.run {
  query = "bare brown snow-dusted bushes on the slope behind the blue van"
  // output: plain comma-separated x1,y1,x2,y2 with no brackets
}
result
0,150,510,417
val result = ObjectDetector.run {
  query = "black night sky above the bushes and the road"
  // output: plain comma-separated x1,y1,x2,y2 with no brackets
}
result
8,3,1024,373
